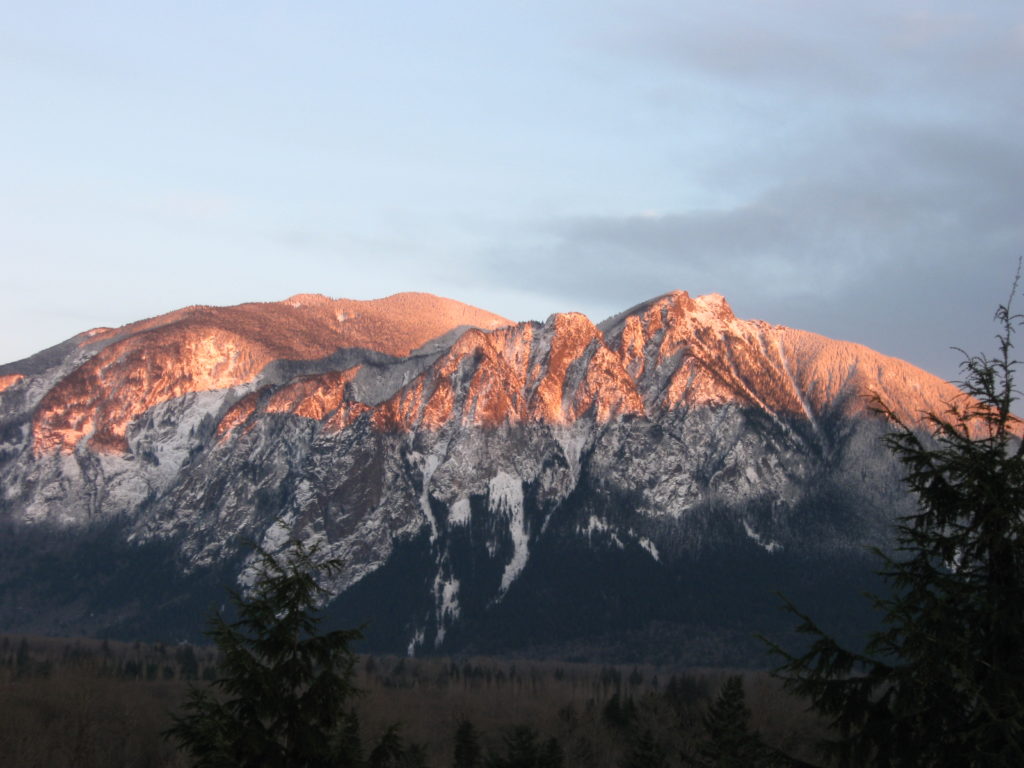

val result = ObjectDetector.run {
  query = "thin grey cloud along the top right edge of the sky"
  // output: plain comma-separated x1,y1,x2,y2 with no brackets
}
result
616,0,1024,102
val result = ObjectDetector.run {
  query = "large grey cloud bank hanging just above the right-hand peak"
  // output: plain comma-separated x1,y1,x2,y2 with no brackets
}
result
492,118,1024,378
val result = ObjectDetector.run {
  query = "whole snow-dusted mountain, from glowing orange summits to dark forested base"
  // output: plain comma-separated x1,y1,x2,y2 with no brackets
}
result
0,292,957,664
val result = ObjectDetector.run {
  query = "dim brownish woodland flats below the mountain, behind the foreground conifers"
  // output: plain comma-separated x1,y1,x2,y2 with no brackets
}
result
0,636,820,768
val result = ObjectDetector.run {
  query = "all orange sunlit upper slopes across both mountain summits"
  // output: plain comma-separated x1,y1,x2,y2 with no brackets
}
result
18,291,974,454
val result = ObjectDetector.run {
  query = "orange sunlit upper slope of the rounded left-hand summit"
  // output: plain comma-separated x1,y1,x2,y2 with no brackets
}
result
33,293,509,452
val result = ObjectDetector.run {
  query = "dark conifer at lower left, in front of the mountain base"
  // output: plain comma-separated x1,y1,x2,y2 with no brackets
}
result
167,543,364,768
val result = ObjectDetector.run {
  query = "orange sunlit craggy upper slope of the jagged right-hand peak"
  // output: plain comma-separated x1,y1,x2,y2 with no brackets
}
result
219,292,958,447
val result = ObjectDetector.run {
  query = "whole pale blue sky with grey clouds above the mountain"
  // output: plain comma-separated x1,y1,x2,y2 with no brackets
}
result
0,0,1024,379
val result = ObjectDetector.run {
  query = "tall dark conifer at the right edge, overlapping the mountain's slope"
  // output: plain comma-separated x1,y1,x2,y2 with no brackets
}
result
775,290,1024,768
